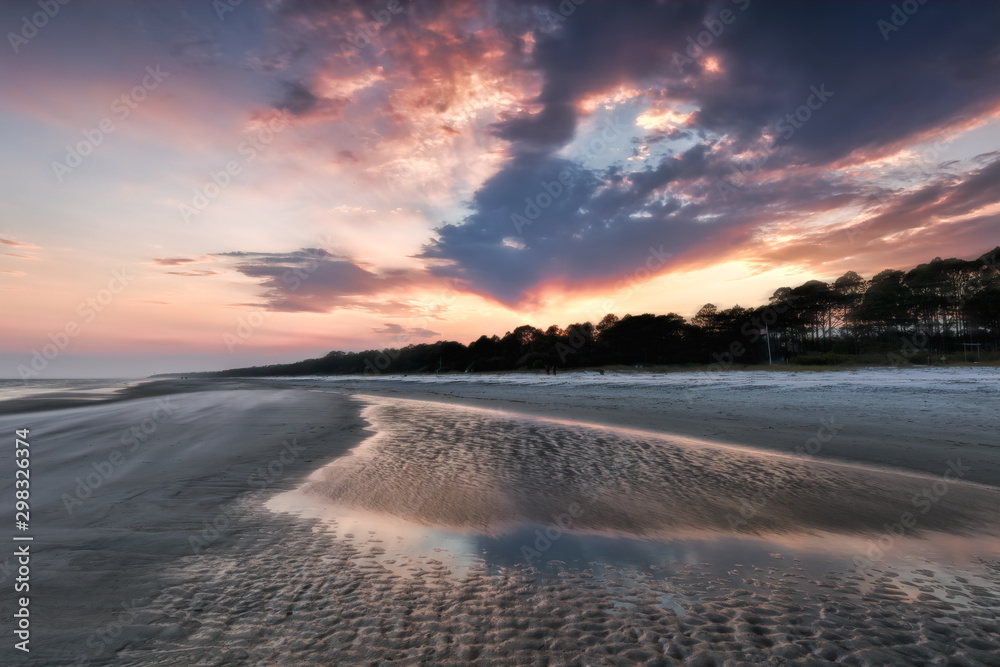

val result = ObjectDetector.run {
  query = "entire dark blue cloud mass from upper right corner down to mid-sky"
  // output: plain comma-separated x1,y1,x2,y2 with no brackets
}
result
422,1,1000,304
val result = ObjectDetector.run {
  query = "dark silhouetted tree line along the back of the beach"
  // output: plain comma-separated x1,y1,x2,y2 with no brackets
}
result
195,246,1000,376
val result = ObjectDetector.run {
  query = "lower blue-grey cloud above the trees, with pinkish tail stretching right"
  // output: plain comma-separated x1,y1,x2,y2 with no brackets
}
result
422,144,860,305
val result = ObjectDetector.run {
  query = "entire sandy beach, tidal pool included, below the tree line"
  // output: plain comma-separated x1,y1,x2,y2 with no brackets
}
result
0,368,1000,665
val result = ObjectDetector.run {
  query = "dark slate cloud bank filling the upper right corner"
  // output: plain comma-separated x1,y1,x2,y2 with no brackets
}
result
488,1,1000,162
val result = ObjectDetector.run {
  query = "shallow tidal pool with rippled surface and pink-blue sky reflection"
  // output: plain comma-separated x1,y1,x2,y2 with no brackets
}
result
268,397,1000,595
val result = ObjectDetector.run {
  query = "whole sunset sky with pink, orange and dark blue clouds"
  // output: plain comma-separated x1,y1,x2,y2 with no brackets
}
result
0,0,1000,379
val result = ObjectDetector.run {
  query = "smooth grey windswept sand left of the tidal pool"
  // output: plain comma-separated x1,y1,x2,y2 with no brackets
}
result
0,390,366,665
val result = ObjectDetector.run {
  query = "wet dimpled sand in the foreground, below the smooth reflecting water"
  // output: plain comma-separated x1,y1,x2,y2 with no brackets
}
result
135,526,1000,665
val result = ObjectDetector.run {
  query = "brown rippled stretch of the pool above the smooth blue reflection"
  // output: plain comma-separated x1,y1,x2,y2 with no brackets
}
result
290,399,1000,537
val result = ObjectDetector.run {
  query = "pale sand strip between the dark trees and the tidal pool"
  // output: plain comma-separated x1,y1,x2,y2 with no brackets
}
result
302,368,1000,486
